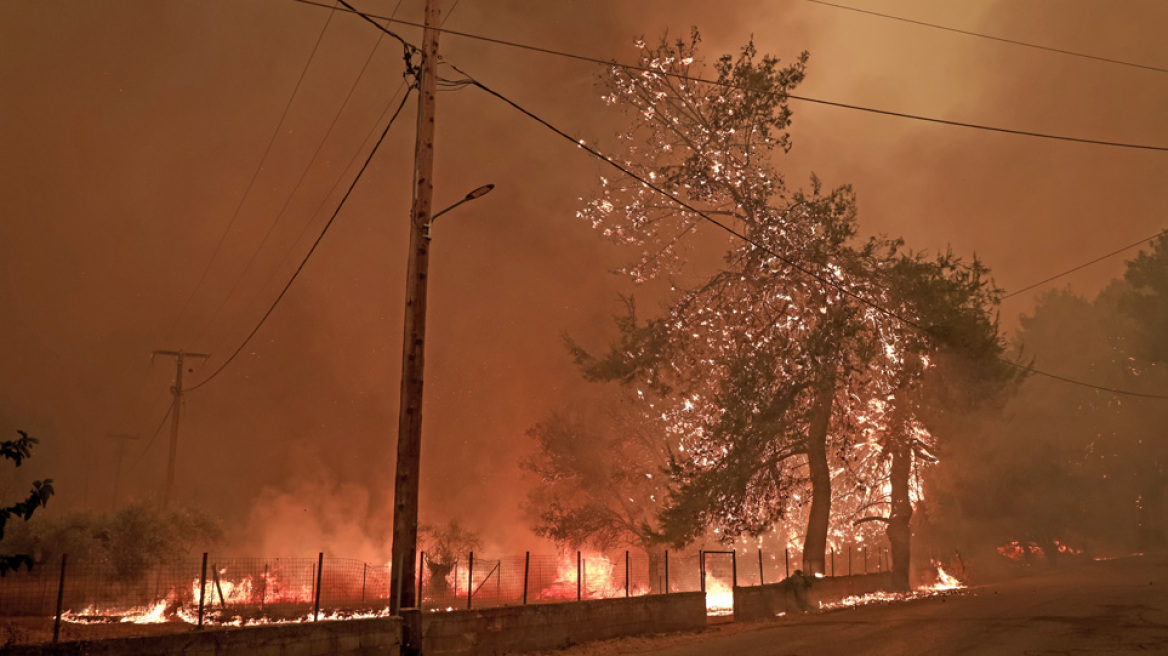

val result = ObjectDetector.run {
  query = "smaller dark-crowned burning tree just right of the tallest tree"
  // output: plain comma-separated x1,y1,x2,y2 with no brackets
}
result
864,253,1021,589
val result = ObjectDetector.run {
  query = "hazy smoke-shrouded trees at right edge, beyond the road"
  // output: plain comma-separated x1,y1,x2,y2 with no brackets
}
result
934,238,1168,561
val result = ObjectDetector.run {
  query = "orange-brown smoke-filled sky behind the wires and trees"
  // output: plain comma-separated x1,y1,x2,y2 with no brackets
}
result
0,0,1168,558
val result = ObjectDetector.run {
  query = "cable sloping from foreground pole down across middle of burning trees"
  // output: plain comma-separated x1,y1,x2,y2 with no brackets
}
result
439,64,1168,400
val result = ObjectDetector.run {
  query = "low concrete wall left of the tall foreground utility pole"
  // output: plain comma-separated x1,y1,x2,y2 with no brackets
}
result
4,617,402,656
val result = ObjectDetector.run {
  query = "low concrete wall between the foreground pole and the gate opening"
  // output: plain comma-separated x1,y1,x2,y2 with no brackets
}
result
422,592,705,656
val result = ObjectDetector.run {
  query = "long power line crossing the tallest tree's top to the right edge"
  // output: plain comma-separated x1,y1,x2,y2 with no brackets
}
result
294,0,1168,152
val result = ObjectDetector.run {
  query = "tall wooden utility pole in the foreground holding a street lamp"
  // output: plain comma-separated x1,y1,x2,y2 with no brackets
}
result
389,0,440,620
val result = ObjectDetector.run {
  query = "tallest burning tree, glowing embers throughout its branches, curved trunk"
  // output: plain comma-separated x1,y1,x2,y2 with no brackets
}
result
575,32,906,572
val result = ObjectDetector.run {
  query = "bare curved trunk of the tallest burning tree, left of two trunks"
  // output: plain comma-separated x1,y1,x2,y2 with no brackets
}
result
802,376,835,577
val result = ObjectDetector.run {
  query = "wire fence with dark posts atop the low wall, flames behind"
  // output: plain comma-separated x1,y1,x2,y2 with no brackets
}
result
0,547,888,648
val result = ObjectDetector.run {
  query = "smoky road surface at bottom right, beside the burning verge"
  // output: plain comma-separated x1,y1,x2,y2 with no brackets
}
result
527,556,1168,656
